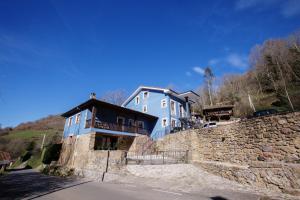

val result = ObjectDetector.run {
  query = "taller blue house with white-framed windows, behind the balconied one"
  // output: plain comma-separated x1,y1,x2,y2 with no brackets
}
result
122,86,198,139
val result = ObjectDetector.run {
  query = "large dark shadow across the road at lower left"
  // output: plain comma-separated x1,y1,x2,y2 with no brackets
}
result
0,170,89,199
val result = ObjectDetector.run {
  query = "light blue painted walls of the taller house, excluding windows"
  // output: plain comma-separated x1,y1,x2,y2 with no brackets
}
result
124,89,186,139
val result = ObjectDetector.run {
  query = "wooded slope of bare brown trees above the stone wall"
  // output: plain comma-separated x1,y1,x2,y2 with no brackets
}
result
197,32,300,116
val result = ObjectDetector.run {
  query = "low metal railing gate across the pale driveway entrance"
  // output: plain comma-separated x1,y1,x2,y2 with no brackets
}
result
125,151,189,165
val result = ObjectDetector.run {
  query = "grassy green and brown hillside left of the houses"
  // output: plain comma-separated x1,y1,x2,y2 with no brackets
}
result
0,115,64,158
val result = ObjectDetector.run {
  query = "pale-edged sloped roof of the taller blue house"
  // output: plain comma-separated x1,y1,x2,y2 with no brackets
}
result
122,86,199,106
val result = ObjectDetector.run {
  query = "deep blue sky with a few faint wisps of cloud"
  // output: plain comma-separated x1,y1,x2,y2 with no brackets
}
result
0,0,300,126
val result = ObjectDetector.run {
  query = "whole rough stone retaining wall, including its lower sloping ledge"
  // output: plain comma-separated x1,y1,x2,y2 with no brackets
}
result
156,112,300,191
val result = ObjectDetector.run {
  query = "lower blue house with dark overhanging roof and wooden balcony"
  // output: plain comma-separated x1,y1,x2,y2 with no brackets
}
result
62,94,158,150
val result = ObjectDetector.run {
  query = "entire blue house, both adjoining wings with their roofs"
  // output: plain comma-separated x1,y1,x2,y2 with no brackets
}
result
62,86,198,150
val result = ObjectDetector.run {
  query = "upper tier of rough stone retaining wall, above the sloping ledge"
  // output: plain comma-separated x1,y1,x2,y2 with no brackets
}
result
157,112,300,163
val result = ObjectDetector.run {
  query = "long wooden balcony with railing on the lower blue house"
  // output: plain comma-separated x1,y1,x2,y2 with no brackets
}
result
85,119,150,135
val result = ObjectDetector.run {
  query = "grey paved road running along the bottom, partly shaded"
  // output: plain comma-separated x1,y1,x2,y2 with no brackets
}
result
0,170,259,200
